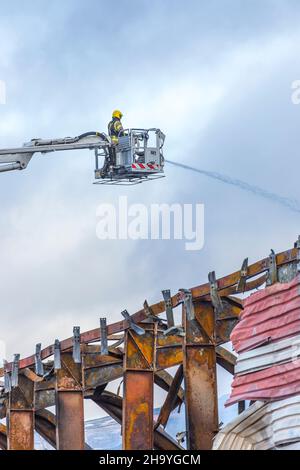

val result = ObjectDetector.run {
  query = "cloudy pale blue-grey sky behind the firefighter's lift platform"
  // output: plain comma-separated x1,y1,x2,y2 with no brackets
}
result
0,0,300,418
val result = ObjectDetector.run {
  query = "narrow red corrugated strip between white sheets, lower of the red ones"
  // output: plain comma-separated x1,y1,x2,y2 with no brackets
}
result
226,359,300,406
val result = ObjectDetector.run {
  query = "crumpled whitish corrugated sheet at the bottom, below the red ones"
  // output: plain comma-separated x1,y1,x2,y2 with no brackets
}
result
213,395,300,450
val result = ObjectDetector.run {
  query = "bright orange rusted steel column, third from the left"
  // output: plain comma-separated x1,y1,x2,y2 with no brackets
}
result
122,323,157,450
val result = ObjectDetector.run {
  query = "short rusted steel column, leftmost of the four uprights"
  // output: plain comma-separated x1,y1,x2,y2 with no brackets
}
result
7,371,34,450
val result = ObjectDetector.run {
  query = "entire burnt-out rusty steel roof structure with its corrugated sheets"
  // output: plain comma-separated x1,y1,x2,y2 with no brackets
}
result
0,239,300,450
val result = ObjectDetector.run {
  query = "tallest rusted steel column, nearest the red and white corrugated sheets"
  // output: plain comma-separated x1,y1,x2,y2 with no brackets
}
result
183,302,218,450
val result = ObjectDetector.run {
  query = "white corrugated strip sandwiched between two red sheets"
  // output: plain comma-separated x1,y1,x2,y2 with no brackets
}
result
234,335,300,375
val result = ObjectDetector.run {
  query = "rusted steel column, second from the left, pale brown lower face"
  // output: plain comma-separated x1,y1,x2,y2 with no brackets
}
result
55,352,84,450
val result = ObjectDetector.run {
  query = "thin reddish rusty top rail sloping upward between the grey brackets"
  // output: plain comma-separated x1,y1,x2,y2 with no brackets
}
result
0,247,298,377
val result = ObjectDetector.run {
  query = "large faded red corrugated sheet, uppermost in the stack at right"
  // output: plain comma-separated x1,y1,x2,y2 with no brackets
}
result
231,275,300,353
